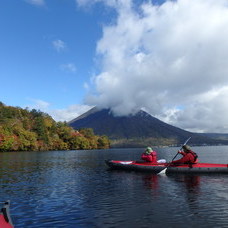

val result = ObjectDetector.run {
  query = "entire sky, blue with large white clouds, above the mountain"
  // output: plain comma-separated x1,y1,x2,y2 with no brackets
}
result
0,0,228,133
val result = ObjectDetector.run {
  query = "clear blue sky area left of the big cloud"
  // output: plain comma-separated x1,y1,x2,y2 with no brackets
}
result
0,0,108,108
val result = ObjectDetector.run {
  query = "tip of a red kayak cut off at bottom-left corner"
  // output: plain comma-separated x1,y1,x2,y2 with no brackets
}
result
0,200,14,228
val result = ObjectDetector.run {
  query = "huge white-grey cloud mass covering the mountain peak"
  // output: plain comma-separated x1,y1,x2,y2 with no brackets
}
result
84,0,228,132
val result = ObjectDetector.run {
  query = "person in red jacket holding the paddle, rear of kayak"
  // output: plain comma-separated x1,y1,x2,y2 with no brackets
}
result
171,145,198,165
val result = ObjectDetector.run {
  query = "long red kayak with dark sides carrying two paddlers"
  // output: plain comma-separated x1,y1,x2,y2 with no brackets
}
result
105,160,228,174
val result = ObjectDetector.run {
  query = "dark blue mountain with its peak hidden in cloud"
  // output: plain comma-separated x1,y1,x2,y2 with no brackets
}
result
68,107,228,147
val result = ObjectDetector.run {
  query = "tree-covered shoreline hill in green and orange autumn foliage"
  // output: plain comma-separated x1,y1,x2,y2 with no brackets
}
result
0,102,110,151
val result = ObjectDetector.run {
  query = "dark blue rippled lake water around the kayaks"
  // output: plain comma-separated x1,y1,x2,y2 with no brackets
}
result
0,146,228,228
